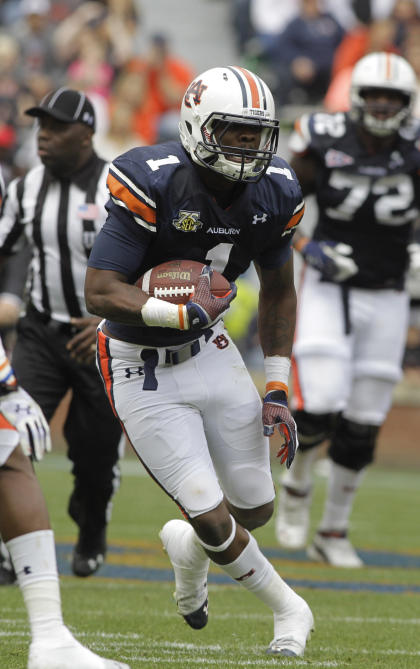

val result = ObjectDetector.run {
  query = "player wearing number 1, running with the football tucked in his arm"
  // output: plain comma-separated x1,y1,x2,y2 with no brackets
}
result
85,67,313,656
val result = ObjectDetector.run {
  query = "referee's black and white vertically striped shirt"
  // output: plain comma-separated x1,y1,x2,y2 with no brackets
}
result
0,154,108,323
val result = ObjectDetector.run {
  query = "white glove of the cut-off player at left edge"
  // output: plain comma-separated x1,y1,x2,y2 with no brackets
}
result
0,388,51,460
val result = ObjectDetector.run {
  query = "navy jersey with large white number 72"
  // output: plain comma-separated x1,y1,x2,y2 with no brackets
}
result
290,112,420,288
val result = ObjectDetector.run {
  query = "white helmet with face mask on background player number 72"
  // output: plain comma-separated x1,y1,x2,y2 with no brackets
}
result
350,52,417,137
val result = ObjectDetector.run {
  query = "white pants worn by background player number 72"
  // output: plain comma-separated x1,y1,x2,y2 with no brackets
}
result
293,267,409,425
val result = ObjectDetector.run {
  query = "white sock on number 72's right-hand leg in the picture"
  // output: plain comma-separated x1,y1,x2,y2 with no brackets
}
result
318,462,365,532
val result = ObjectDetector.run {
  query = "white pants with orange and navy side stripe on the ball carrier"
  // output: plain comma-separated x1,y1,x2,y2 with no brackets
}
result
98,321,274,518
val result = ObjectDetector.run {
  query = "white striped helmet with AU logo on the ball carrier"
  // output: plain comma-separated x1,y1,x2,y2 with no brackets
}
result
179,66,279,182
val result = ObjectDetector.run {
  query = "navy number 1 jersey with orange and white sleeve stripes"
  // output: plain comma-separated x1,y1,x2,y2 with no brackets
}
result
89,141,304,346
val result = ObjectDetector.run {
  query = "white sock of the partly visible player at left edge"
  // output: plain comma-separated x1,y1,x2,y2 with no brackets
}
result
6,530,64,640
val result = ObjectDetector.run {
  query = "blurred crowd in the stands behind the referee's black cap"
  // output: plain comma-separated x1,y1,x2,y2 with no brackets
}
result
0,0,194,181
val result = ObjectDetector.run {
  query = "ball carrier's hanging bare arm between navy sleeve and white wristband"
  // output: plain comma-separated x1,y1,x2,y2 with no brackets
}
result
257,255,296,357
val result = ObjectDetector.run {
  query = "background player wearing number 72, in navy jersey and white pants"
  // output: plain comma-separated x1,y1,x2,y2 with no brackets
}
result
276,53,420,567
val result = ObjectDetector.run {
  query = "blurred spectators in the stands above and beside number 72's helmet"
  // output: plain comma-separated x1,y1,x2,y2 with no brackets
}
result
232,0,420,111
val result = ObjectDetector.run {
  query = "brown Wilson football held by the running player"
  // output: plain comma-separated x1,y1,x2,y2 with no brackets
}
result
136,260,230,304
